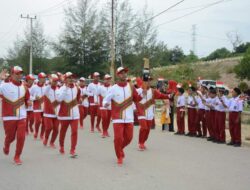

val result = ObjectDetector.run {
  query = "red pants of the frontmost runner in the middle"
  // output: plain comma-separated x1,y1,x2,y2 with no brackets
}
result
113,123,134,158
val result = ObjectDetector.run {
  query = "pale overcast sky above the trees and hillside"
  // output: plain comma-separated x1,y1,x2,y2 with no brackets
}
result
0,0,250,57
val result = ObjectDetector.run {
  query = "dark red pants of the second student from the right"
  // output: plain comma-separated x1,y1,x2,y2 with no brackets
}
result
215,111,226,142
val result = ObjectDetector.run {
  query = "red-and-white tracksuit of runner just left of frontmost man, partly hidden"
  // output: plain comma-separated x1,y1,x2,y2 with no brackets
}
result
99,84,111,137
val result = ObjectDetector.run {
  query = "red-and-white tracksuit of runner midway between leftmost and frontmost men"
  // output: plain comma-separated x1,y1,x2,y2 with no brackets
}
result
56,84,81,155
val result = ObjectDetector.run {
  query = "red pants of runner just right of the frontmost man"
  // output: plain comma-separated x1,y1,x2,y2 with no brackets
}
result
139,119,153,144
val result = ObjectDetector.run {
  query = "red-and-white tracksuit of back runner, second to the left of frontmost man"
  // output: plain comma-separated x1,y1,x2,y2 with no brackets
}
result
87,82,101,132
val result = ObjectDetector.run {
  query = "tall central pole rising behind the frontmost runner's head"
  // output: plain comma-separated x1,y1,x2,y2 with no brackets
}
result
110,0,115,80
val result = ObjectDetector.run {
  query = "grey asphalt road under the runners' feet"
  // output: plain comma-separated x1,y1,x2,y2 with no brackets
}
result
0,118,250,190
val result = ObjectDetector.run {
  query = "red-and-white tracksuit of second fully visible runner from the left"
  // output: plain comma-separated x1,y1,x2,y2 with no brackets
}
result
30,82,45,139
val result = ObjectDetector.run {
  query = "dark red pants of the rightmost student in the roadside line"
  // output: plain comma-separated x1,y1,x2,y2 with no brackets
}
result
229,112,241,143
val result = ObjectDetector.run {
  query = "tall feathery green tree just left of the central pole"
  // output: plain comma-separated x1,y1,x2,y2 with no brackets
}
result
54,0,107,76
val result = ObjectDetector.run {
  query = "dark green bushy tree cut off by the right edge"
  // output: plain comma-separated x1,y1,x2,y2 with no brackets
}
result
234,48,250,80
